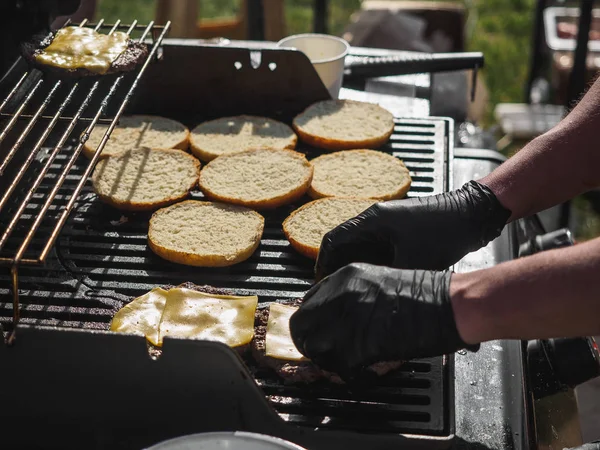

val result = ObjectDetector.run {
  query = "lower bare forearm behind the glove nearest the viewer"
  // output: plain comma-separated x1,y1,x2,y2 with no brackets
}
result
450,238,600,343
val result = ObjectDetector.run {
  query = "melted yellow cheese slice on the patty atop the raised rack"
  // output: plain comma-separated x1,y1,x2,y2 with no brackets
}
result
35,27,129,74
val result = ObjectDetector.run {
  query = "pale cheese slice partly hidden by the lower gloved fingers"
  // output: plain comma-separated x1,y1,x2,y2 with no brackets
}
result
265,303,306,361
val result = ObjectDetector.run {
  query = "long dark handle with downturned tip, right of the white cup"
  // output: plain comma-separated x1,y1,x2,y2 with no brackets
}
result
344,52,484,100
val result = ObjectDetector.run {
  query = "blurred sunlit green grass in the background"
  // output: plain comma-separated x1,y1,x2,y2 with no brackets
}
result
97,0,535,117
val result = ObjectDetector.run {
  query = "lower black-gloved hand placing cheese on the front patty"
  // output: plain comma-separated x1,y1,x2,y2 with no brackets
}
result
290,263,477,378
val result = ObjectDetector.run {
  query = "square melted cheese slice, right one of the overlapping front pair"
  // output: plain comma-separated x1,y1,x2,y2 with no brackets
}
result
156,288,258,347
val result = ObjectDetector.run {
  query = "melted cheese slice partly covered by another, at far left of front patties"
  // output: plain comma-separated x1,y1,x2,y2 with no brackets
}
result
110,288,169,343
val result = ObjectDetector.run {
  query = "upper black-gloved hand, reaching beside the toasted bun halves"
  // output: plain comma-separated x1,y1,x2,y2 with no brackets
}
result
316,181,511,280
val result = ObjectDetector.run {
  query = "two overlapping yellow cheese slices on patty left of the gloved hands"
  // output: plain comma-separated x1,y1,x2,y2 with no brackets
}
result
110,288,258,347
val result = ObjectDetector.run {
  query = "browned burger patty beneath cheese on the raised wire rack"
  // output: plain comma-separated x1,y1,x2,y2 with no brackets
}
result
21,29,148,77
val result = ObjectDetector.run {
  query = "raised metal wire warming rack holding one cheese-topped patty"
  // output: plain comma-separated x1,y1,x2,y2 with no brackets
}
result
0,20,170,342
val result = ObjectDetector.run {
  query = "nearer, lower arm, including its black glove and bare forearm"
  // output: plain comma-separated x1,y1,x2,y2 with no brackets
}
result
290,238,600,376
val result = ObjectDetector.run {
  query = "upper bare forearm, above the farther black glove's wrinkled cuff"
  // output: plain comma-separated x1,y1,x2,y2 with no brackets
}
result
480,79,600,220
